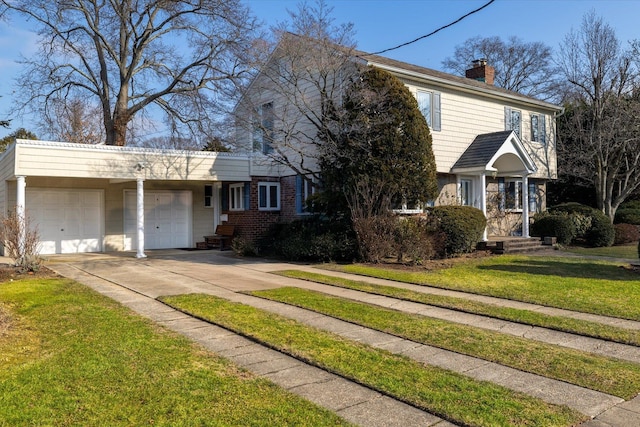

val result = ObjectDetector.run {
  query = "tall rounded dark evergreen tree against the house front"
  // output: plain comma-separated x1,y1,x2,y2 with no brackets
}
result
322,67,437,216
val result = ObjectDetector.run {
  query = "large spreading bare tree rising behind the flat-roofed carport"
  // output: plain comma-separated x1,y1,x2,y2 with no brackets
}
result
0,0,255,145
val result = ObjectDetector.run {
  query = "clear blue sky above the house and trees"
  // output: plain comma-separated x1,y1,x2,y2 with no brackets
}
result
0,0,640,137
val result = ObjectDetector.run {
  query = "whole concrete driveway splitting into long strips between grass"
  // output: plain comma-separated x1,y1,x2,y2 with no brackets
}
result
45,251,640,427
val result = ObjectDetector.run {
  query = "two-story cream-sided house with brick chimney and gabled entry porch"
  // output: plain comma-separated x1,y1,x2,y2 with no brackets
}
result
231,36,562,238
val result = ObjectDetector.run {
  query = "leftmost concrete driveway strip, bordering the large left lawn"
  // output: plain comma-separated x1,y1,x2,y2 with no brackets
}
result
49,263,444,427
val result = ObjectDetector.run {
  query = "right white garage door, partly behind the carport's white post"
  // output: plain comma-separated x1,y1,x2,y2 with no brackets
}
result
124,190,192,250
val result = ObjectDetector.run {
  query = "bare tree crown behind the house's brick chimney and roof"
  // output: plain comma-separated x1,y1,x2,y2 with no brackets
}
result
442,36,558,100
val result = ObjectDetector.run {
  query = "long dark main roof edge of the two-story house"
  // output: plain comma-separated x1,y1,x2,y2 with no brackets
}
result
354,51,562,110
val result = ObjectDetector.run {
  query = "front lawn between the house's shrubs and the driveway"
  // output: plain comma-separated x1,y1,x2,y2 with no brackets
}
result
327,255,640,320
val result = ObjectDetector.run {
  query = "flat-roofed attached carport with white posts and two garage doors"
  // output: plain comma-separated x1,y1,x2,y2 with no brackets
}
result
0,139,258,258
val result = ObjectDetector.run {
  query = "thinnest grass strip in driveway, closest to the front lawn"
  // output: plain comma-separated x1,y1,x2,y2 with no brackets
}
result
273,270,640,346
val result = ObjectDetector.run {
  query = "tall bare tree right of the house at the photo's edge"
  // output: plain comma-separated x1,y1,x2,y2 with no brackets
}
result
558,12,640,220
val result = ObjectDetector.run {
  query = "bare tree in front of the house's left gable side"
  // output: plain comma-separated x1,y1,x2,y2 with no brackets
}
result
236,0,355,178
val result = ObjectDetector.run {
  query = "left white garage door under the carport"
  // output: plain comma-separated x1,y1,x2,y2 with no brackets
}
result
26,188,104,254
